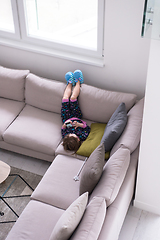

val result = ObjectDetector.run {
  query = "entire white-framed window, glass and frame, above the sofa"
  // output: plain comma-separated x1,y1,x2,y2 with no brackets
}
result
0,0,104,57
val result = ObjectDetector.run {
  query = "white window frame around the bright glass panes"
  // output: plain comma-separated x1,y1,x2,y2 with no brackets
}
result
0,0,105,63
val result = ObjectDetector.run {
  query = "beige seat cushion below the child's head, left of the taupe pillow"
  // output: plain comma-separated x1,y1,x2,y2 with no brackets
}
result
31,155,83,209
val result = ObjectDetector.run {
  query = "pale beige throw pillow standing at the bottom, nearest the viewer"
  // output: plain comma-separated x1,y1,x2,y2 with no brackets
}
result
49,193,88,240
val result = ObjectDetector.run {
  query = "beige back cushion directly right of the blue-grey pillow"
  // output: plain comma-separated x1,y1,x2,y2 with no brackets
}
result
111,98,144,155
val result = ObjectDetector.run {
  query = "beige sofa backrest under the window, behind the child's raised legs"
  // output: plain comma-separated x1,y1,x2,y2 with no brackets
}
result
25,73,137,123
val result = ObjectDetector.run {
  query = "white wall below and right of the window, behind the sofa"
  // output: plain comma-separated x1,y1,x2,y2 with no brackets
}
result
0,0,150,98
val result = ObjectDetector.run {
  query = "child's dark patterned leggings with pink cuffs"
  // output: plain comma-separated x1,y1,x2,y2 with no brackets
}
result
61,99,82,123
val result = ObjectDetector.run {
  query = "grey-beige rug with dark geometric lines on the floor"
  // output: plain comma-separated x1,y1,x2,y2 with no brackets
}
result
0,167,42,240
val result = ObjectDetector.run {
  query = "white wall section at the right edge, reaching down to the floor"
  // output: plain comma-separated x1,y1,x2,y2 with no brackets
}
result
134,40,160,215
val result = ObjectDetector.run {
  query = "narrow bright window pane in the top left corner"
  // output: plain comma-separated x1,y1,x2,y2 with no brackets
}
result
0,0,15,32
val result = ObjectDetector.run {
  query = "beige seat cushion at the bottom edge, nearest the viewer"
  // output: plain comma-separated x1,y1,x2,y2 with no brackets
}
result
6,200,64,240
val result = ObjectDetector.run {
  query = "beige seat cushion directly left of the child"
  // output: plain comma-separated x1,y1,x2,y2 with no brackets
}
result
3,105,61,155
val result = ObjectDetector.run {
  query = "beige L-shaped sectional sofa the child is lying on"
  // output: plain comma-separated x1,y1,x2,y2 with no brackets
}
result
0,67,144,240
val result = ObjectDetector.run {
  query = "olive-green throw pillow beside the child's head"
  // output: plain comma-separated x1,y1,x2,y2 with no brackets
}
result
76,123,109,159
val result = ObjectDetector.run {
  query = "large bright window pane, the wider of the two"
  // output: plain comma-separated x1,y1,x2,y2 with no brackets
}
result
24,0,98,50
